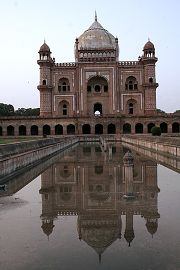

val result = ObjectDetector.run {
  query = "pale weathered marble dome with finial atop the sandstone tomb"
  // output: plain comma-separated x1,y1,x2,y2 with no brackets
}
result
78,16,116,49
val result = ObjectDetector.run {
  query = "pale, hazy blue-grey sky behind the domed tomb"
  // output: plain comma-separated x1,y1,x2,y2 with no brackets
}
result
0,0,180,112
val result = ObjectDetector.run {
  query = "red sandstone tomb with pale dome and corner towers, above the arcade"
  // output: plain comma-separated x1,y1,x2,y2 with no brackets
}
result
38,15,158,117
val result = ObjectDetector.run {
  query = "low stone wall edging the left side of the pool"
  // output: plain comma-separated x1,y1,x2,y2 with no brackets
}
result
0,137,79,182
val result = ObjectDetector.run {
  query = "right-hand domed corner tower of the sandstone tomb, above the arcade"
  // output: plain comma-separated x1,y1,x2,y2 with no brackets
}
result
140,40,158,115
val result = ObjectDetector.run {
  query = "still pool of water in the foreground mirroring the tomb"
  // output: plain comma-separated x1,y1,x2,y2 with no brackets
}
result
0,143,180,270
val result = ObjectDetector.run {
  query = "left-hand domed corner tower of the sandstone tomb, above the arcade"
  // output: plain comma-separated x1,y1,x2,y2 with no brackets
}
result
37,41,54,116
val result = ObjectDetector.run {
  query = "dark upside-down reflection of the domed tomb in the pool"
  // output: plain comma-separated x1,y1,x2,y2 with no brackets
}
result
40,145,160,254
